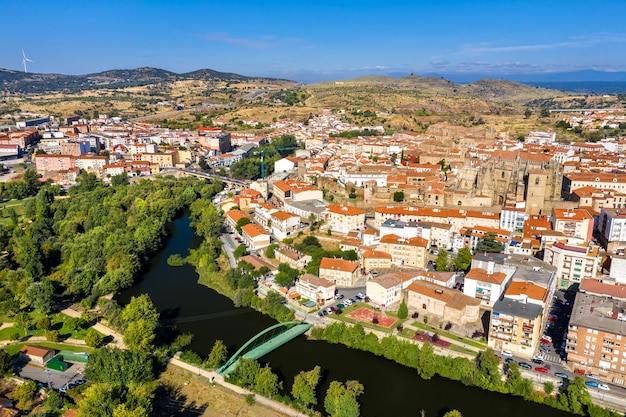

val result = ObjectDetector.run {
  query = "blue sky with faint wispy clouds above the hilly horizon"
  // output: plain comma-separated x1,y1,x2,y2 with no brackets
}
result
0,0,626,82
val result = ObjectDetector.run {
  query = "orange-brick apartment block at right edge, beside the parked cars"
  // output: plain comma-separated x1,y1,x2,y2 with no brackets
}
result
565,279,626,386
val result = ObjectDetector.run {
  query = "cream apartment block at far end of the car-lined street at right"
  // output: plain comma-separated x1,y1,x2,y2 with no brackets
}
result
543,241,600,289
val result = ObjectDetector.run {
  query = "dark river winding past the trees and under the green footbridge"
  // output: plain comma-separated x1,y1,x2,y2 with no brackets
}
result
116,217,571,417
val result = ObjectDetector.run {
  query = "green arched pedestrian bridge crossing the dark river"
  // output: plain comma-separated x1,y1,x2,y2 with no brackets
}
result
216,321,313,376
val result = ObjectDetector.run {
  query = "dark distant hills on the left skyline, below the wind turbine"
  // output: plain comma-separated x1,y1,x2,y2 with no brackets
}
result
0,67,293,94
